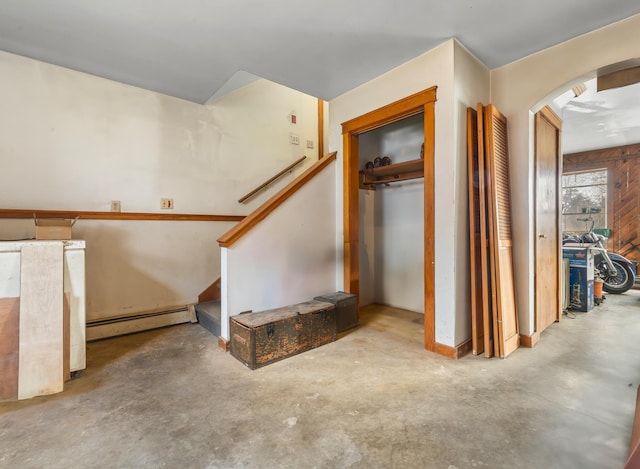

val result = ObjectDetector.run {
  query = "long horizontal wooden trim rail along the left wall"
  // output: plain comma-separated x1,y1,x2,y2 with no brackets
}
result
0,208,245,221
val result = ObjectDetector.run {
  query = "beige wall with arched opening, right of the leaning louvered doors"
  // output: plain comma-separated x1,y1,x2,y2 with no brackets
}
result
491,15,640,335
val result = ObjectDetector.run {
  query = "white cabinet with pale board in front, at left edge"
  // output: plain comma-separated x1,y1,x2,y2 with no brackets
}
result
0,240,86,399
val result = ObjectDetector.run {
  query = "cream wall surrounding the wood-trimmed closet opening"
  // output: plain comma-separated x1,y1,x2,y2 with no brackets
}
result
329,40,475,346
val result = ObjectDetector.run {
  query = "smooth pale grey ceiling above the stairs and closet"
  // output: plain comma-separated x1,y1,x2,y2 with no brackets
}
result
0,0,640,103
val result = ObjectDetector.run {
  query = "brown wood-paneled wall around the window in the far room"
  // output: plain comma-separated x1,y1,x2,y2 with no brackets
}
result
563,143,640,262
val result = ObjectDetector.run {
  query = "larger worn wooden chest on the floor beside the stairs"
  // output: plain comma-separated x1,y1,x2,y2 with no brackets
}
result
230,300,336,370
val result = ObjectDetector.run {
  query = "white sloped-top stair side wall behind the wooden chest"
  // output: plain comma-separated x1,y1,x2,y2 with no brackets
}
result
221,161,337,339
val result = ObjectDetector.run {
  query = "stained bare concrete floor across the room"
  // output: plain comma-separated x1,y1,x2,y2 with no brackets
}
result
0,291,640,469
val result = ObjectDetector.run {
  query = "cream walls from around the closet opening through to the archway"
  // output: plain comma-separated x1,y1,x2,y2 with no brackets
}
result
330,15,640,346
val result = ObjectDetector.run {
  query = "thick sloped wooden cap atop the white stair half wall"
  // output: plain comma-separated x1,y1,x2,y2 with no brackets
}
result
218,151,337,248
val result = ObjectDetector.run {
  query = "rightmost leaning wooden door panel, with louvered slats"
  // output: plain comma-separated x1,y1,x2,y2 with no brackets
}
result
484,105,520,357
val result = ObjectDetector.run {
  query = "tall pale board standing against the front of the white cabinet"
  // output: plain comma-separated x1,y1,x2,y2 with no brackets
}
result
18,242,64,399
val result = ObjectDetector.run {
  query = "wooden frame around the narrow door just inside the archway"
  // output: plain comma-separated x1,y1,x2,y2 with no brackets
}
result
525,106,562,347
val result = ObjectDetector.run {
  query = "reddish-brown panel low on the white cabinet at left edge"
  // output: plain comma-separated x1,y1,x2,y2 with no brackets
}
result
0,298,20,399
